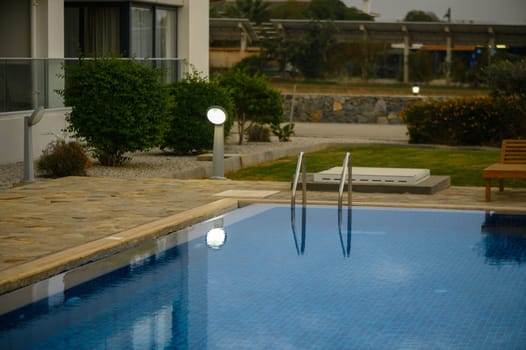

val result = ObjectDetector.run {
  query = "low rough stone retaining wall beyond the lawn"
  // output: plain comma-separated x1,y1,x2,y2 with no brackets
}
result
283,94,447,124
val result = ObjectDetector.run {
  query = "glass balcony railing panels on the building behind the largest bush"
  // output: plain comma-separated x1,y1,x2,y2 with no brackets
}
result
0,58,185,113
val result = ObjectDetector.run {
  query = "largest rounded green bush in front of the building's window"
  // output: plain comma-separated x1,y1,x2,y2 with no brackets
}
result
62,58,168,166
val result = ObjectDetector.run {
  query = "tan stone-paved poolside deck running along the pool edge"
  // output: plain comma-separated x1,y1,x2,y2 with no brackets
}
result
0,126,526,295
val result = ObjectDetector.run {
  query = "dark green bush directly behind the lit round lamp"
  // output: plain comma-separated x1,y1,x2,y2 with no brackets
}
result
161,72,234,154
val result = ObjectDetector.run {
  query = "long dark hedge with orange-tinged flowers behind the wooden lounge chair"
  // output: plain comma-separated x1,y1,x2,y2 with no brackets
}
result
400,97,526,146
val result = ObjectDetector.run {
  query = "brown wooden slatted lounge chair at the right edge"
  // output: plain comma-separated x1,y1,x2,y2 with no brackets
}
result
482,140,526,202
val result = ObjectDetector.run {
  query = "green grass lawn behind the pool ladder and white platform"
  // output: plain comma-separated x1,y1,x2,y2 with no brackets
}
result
227,146,526,187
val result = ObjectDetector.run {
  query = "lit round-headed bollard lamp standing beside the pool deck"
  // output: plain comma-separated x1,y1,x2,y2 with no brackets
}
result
206,106,226,179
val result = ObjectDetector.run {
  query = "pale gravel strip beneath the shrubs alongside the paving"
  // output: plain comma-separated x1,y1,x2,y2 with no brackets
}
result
0,137,335,190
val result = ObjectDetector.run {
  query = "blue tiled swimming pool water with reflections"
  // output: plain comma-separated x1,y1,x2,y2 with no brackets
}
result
0,205,526,350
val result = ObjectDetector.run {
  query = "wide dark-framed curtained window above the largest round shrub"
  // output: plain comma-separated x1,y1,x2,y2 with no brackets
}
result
64,1,177,58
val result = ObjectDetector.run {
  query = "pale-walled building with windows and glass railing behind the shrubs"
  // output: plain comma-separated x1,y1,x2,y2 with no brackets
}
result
0,0,209,164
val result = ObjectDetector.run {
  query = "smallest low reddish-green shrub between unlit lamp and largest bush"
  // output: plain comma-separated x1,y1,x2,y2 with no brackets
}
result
37,139,91,177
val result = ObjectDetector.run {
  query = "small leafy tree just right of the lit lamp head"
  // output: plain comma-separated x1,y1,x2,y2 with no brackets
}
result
218,69,283,145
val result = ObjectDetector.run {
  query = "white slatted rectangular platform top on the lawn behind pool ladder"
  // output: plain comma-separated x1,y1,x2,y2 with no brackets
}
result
313,167,431,184
